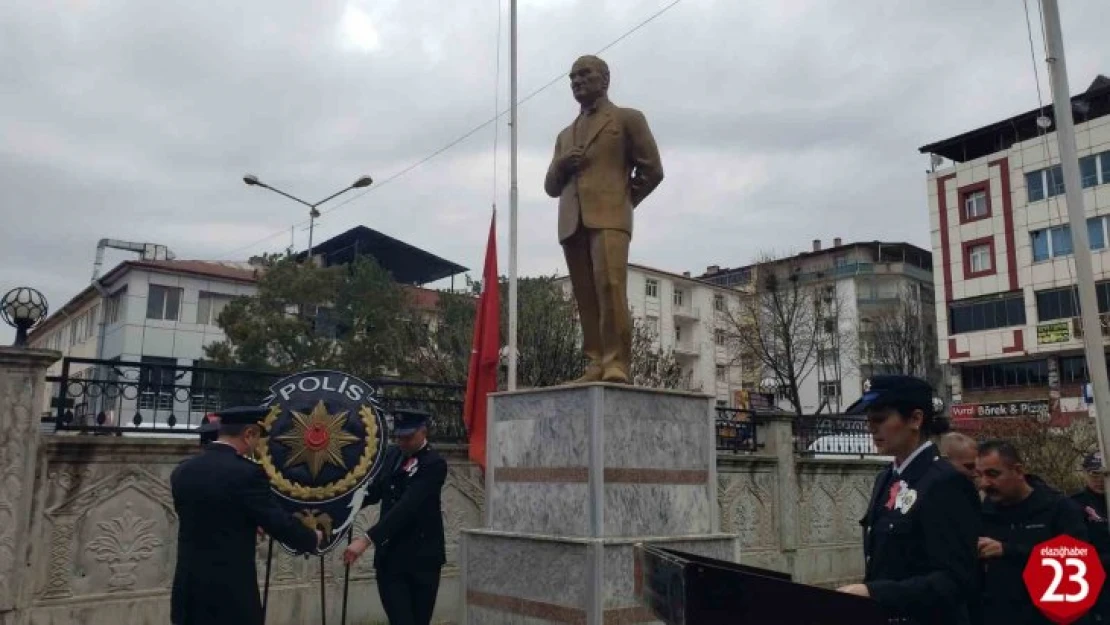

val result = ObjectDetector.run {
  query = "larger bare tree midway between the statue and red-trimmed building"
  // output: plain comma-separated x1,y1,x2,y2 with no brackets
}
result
724,256,854,415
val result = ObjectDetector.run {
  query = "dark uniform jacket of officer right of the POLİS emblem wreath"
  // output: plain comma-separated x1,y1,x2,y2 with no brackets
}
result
365,444,447,572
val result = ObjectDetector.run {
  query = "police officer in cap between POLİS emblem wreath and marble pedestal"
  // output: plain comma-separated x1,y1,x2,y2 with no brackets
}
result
343,410,447,625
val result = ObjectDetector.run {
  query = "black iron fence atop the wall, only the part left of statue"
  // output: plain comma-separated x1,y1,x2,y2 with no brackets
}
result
43,357,466,443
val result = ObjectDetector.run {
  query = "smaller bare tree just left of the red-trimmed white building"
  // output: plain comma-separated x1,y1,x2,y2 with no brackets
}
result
860,285,941,385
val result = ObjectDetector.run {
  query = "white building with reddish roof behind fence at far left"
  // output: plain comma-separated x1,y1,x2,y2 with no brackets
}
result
29,260,256,423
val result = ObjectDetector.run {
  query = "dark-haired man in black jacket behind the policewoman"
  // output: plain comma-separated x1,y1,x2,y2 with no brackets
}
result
977,441,1088,625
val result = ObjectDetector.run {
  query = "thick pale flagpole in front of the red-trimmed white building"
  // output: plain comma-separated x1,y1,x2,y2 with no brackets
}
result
1042,0,1110,497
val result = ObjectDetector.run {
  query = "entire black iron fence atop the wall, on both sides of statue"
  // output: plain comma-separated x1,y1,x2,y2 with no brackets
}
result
42,357,877,455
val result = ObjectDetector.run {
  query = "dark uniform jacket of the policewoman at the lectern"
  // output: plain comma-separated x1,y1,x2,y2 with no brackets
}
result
860,444,979,625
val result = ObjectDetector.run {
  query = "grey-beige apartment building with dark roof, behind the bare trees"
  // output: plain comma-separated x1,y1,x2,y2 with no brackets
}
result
700,239,939,413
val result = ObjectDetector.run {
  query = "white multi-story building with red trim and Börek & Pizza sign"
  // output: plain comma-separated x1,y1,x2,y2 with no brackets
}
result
920,75,1110,422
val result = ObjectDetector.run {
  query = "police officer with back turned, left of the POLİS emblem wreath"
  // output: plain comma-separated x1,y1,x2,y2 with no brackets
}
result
170,407,321,625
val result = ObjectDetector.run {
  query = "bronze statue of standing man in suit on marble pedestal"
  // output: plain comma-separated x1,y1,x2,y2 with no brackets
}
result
544,57,663,384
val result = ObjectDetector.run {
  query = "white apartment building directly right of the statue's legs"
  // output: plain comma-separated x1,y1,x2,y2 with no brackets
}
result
558,263,744,406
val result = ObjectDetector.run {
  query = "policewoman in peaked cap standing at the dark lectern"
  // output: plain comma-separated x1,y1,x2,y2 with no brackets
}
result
840,375,980,625
